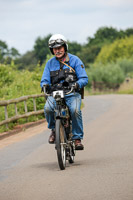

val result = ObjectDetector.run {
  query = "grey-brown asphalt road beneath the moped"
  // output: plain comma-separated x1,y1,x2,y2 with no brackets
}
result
0,95,133,200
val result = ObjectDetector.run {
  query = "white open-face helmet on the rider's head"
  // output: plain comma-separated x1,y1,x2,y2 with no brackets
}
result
48,34,68,54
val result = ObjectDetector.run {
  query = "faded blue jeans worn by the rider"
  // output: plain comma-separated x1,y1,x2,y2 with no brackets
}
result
44,93,84,140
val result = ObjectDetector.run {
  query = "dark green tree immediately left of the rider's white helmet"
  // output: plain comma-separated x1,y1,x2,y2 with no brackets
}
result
34,34,51,65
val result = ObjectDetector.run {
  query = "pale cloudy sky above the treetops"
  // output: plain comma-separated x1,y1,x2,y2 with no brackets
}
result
0,0,133,54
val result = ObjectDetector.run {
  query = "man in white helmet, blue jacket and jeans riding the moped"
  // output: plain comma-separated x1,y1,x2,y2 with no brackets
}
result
40,34,88,150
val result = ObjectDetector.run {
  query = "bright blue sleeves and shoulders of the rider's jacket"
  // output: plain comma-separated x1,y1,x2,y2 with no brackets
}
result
40,53,88,88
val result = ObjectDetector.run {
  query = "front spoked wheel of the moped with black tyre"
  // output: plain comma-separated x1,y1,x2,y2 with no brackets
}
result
55,119,66,170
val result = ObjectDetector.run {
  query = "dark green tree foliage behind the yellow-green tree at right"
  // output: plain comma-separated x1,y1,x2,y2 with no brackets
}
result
80,27,133,65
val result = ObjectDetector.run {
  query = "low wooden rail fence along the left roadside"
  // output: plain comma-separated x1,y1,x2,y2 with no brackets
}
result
0,94,44,128
